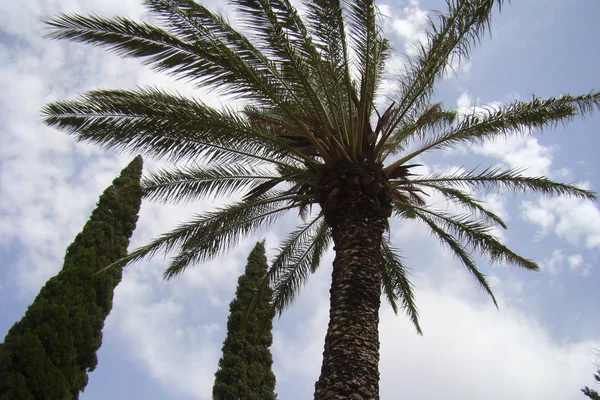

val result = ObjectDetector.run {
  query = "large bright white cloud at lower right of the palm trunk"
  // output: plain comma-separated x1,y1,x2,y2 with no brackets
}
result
381,290,598,400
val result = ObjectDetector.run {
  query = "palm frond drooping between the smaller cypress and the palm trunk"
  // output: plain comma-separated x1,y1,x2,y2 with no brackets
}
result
264,214,331,315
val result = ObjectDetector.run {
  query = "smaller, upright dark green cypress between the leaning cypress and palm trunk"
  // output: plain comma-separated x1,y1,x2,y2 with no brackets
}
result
213,241,277,400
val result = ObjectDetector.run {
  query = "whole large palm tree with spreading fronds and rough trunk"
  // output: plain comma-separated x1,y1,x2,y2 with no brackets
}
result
43,0,600,399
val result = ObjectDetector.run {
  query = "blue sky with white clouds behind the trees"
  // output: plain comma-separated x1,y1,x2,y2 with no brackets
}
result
0,0,600,400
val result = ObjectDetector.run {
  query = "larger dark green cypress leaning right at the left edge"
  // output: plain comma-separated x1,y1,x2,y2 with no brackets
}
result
0,156,142,400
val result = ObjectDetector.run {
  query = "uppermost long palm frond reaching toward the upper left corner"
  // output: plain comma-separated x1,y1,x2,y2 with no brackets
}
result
47,14,262,99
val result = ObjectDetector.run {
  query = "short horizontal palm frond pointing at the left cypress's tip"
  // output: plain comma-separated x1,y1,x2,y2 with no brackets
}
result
142,165,296,204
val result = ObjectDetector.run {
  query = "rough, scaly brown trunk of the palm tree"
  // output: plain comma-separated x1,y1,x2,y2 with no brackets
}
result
315,191,387,400
